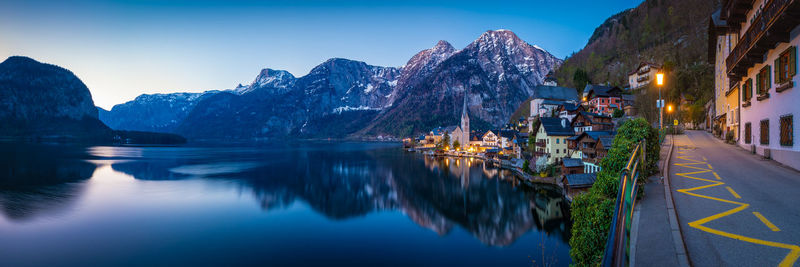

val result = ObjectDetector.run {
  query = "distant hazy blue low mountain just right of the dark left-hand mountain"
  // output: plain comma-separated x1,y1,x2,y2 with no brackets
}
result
99,91,219,132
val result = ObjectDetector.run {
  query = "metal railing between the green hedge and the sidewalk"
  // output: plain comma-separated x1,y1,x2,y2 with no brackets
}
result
603,139,646,266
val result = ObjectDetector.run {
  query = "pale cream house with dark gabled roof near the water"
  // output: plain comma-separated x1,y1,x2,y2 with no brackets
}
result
533,117,575,164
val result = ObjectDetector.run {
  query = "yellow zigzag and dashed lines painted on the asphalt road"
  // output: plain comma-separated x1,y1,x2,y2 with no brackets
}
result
674,152,800,267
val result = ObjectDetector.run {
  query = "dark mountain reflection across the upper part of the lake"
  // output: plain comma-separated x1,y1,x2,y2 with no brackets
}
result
0,143,570,265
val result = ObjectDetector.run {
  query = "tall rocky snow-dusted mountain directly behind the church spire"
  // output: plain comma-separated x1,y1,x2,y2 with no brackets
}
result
361,30,562,136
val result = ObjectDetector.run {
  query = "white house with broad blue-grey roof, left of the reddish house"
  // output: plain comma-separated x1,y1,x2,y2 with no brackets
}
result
528,85,580,127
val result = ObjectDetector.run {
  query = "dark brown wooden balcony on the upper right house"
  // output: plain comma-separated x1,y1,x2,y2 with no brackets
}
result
725,0,800,81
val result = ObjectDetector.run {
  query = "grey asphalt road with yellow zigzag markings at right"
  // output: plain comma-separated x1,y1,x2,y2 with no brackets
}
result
665,131,800,266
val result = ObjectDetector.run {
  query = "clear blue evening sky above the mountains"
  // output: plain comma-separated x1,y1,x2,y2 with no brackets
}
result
0,0,641,108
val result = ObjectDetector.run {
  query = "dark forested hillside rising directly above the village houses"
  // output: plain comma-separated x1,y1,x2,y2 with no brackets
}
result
555,0,718,102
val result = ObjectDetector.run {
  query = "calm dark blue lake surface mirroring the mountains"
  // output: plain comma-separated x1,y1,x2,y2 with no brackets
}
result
0,143,570,266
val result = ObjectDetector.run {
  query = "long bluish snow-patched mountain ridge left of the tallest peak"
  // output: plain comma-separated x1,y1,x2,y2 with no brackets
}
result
177,58,400,139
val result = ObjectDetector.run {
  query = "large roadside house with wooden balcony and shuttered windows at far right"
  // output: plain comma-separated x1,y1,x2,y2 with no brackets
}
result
709,0,800,169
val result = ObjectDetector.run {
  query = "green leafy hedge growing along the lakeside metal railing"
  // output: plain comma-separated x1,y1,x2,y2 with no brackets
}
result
569,118,661,266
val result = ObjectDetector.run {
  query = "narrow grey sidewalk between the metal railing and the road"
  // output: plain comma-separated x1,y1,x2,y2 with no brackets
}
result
630,137,689,266
